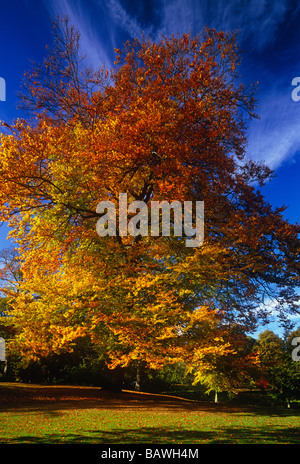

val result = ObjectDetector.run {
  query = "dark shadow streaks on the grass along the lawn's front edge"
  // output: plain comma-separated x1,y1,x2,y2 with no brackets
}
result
1,427,300,445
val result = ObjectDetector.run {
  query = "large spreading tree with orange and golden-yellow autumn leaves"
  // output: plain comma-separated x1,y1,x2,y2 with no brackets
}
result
0,16,299,382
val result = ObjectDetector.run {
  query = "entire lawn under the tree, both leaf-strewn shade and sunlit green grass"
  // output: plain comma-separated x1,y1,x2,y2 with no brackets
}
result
0,383,300,444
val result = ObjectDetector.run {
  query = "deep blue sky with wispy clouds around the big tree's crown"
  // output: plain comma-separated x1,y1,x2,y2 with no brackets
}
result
0,0,300,334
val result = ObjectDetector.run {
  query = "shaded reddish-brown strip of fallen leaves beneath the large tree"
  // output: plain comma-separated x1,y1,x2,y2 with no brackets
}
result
0,384,300,417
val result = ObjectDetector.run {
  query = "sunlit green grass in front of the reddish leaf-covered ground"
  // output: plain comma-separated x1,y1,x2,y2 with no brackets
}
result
0,409,300,444
